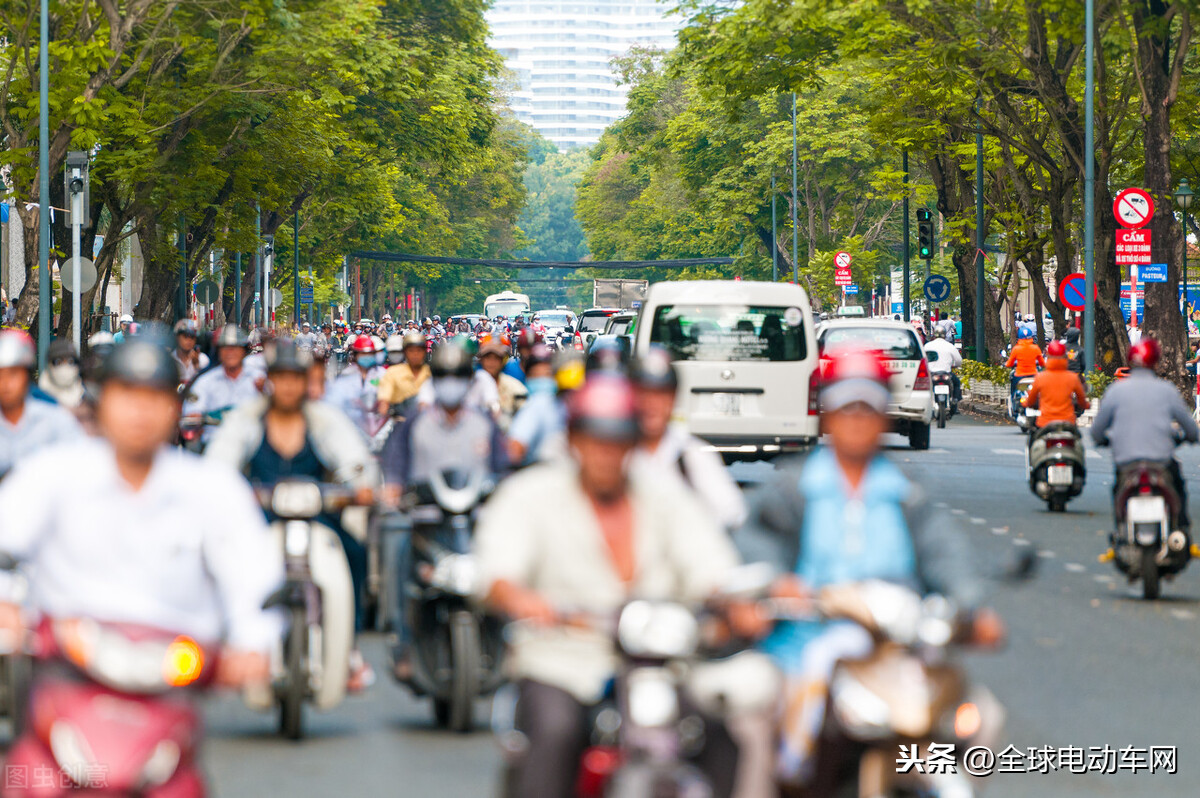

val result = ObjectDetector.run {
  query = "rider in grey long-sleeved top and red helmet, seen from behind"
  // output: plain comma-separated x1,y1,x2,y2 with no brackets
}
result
1092,337,1200,533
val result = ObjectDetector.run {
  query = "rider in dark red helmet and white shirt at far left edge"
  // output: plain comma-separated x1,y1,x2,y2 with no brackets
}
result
0,330,83,472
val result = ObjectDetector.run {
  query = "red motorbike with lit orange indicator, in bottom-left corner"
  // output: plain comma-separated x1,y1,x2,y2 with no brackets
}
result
5,618,216,798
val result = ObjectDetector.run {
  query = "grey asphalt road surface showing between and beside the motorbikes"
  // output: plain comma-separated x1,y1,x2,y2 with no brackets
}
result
16,416,1200,798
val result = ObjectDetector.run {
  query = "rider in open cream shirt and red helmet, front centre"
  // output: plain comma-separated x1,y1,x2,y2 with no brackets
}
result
474,374,737,798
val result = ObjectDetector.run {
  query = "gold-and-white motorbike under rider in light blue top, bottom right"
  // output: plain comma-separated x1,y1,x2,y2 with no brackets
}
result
766,581,1004,798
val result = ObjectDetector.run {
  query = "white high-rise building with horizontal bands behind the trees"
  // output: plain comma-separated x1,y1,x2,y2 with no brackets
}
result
487,0,678,149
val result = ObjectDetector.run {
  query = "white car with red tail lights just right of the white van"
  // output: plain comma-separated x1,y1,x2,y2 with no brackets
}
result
817,318,934,449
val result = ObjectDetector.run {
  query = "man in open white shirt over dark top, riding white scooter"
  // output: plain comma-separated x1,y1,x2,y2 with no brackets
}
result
204,340,379,690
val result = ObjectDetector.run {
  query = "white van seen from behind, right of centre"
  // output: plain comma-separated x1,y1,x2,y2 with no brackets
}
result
634,281,818,460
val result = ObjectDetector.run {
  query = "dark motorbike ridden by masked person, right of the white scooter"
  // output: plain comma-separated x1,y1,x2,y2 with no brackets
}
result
384,472,504,732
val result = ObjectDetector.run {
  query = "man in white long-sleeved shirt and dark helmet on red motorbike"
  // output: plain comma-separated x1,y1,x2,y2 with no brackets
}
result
0,340,283,685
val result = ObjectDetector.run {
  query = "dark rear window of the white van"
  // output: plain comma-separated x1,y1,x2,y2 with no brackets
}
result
650,305,806,361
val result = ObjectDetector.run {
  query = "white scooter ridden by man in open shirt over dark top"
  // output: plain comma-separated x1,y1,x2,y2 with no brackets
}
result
244,479,355,739
